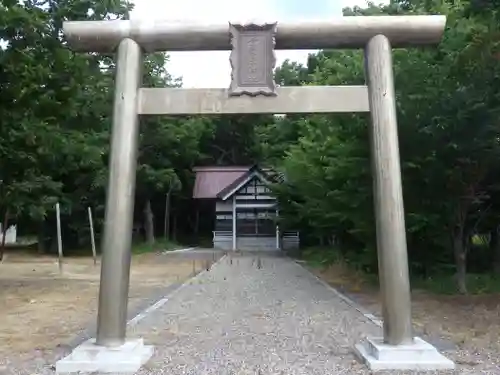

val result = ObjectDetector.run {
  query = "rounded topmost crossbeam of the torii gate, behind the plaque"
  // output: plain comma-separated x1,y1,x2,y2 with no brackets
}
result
63,15,446,53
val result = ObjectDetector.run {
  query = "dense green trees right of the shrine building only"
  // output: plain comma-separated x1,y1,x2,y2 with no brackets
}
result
270,2,500,292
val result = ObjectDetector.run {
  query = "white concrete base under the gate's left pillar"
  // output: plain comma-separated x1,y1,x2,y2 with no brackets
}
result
56,339,154,374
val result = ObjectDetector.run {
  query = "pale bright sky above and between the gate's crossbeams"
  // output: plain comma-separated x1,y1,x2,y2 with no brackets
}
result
131,0,366,88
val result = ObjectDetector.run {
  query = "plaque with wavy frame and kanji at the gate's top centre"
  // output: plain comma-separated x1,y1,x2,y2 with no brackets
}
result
229,23,277,96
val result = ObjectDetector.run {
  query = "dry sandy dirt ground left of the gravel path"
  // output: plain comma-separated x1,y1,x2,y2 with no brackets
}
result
0,253,206,358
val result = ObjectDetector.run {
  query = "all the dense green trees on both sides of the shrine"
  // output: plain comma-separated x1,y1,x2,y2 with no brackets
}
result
0,0,500,292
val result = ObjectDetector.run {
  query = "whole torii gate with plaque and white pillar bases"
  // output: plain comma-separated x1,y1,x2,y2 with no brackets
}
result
56,16,454,373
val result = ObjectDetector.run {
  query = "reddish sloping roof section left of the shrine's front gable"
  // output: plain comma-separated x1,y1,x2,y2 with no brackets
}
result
193,165,252,199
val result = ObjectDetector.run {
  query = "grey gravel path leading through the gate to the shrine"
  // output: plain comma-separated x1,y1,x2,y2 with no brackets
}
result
131,255,380,375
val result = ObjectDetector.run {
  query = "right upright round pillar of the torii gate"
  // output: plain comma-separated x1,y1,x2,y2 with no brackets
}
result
365,35,413,345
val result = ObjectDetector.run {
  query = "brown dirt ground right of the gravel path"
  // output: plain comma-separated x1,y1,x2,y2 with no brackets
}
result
310,265,500,352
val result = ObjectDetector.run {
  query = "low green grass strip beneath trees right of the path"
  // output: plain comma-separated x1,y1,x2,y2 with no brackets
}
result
302,247,500,295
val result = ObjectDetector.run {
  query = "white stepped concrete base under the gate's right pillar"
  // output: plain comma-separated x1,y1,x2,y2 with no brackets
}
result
355,337,455,371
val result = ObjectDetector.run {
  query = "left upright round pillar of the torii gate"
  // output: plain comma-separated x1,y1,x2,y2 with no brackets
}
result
96,39,142,347
